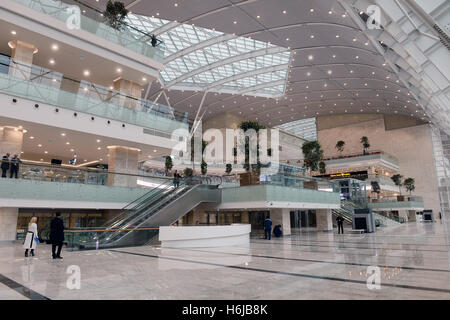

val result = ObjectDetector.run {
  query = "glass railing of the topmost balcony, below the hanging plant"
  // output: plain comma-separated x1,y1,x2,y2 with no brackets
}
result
4,0,164,62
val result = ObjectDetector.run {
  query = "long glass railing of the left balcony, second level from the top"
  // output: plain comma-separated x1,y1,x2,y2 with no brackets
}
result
0,55,188,136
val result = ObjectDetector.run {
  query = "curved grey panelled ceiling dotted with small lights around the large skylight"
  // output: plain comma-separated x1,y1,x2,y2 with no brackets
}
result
79,0,450,132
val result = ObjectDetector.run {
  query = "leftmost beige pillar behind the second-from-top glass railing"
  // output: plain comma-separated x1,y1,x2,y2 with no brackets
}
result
8,40,38,79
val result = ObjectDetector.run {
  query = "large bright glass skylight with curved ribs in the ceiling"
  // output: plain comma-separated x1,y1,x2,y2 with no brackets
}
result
127,14,290,97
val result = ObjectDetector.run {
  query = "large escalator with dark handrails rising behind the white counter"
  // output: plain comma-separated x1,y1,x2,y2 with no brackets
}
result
69,177,220,250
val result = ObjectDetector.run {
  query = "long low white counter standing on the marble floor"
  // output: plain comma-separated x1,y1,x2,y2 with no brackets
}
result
159,224,251,248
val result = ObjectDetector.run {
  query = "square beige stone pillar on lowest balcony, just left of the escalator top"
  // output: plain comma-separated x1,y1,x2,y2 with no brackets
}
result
108,146,140,187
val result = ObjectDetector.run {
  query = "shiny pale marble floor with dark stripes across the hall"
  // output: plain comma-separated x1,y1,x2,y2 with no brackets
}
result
0,222,450,300
